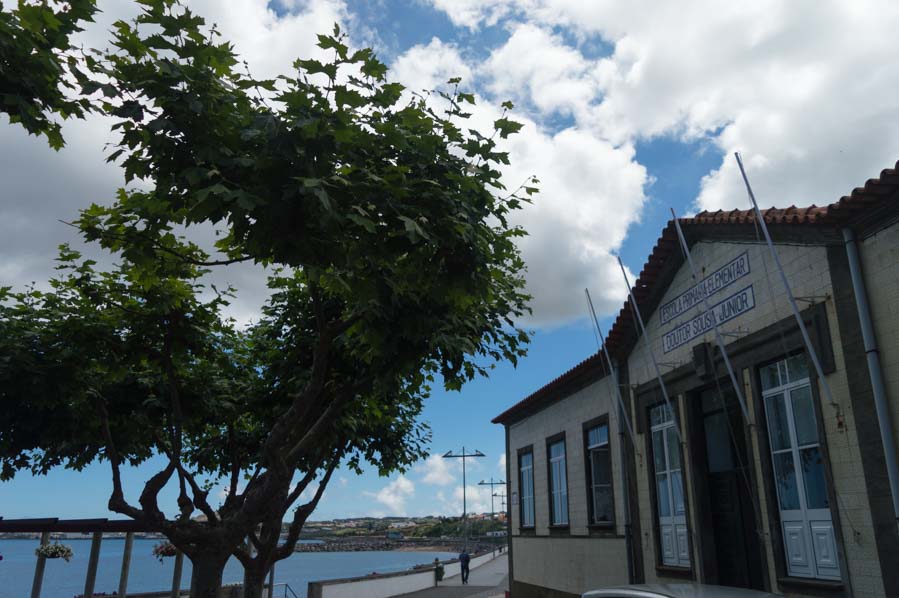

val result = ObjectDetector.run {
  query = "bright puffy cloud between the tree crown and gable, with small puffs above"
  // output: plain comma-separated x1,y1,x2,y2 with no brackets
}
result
392,42,647,326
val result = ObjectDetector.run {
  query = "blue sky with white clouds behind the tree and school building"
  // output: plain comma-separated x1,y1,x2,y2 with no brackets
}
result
0,0,899,518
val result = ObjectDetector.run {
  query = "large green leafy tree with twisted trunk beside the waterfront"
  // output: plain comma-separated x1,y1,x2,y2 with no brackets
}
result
0,0,536,597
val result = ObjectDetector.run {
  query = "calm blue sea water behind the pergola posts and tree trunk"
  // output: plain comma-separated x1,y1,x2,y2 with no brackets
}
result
0,538,457,598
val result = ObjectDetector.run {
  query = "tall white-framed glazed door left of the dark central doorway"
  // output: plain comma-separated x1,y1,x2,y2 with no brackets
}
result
649,404,691,568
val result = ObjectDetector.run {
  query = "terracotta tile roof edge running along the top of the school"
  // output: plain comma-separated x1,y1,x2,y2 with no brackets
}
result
493,161,899,424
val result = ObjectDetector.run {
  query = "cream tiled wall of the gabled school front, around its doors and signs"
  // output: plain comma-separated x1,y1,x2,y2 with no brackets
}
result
628,242,884,597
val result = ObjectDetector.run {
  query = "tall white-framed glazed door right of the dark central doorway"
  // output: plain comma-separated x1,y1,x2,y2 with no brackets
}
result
762,356,842,580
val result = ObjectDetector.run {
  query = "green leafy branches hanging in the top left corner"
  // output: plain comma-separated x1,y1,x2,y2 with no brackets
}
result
0,0,97,150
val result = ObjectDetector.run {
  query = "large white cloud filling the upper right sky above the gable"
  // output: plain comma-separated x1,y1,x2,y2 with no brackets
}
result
432,0,899,218
